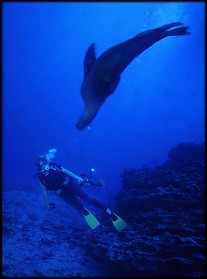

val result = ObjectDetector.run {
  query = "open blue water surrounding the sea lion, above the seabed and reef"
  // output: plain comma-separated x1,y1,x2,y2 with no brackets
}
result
2,2,205,278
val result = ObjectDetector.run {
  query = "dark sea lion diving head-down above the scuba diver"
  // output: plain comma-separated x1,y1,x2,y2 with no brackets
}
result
76,22,190,130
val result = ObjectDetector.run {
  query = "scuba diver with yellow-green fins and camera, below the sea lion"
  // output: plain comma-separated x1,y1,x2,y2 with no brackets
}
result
35,149,127,232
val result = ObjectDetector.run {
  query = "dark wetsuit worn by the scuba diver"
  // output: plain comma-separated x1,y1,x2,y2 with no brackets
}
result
38,163,107,212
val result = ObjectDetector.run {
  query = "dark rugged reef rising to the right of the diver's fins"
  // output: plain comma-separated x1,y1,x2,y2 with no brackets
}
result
90,143,205,276
